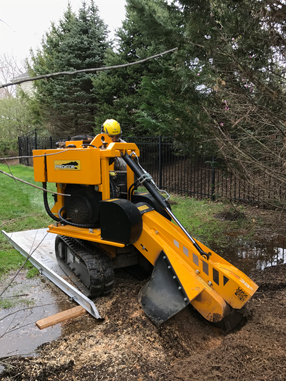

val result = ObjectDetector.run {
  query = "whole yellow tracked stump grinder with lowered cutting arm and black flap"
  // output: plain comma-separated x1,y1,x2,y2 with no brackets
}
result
33,134,257,329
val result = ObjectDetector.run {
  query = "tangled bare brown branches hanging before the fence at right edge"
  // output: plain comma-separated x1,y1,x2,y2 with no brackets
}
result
206,65,286,208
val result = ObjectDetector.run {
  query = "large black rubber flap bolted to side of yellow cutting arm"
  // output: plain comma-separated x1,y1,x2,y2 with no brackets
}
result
139,251,189,326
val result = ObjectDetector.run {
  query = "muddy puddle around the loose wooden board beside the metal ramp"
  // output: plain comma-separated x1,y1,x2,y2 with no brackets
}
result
0,273,95,364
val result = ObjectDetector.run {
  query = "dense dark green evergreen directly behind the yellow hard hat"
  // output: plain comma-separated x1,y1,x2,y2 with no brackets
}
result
93,0,210,140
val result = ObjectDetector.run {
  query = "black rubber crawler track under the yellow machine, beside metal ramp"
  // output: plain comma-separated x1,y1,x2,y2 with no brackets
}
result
55,236,114,297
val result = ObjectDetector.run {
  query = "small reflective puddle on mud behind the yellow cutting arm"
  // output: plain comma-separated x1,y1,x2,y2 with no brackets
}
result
213,235,286,275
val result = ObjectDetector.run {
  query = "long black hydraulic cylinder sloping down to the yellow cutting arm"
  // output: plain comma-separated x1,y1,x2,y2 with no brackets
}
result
122,154,211,259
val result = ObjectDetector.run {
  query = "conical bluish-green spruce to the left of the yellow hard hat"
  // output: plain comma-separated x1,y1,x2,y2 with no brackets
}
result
31,1,108,136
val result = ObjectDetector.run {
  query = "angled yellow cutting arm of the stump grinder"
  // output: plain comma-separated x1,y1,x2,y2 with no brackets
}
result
134,211,257,325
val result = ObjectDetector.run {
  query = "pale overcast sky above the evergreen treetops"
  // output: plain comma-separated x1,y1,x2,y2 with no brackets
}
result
0,0,125,65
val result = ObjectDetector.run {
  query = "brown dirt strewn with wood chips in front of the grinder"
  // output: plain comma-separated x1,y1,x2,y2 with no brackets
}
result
0,209,286,381
